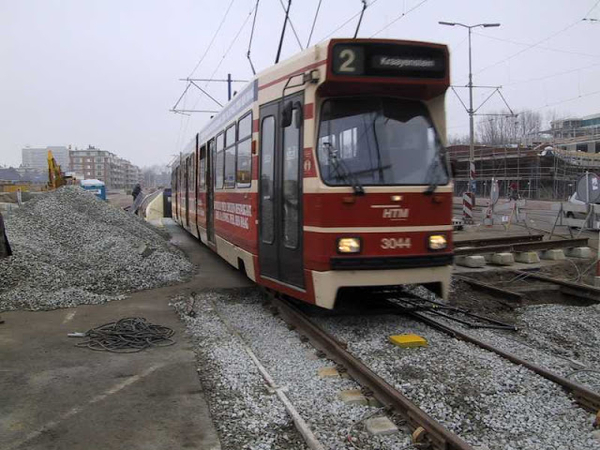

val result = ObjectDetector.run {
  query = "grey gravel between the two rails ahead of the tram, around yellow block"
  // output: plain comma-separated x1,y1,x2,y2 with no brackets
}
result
317,316,600,450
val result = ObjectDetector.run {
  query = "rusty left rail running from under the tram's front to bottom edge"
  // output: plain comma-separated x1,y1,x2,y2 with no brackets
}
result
269,295,473,450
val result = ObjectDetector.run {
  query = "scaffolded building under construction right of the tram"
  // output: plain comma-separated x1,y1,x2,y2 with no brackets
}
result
448,142,600,200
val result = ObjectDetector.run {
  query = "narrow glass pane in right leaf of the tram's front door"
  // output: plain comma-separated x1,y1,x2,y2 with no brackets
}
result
283,108,300,248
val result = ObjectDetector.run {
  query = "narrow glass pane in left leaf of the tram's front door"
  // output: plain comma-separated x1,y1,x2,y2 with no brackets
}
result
260,116,275,244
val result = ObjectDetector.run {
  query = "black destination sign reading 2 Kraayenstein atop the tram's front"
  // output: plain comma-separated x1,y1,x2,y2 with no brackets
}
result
331,43,447,78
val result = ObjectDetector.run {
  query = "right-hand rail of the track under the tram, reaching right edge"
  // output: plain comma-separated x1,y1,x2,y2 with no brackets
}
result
409,312,600,413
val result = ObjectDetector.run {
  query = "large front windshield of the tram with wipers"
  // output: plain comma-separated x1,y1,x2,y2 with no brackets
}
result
318,97,449,186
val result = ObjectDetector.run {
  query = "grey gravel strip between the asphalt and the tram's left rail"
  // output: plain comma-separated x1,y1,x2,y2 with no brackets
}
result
180,289,413,450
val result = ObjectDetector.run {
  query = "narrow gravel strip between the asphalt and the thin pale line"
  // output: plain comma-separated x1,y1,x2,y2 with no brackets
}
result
173,293,306,450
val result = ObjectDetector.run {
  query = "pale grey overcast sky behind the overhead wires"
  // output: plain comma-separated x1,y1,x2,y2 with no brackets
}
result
0,0,600,166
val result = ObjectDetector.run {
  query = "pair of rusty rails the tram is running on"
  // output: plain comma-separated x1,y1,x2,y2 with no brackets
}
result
270,288,600,450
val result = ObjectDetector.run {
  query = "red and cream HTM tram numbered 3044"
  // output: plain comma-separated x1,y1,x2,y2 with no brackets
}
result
172,39,453,308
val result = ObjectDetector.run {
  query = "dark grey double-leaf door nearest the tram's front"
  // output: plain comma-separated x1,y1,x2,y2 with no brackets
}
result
258,94,304,288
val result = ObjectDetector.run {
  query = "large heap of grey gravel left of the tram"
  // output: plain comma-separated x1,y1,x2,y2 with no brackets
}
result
0,186,194,311
